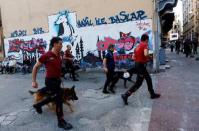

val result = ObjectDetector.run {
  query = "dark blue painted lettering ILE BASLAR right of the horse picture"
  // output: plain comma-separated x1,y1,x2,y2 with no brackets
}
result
77,10,147,28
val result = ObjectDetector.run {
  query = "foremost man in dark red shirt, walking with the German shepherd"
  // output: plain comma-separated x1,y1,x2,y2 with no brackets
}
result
32,37,72,130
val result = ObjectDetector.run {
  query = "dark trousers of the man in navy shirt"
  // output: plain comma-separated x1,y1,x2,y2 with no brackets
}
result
103,70,115,91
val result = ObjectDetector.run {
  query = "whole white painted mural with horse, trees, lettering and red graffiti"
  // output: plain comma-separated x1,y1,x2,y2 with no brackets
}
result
5,10,153,68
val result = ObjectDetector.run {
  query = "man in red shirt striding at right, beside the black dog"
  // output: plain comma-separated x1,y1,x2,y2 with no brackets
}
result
121,34,160,105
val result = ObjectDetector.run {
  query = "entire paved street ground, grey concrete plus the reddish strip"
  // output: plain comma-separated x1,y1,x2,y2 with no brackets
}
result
0,49,199,131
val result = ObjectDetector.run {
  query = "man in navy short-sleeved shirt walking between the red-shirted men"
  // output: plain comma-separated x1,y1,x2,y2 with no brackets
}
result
102,44,115,94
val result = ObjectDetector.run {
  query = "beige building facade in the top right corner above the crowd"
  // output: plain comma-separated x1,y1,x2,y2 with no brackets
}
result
183,0,199,40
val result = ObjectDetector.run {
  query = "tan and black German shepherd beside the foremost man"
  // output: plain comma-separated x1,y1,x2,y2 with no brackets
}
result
29,86,78,112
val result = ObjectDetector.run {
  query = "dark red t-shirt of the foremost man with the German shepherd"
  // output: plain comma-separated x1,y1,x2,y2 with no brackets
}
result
39,51,62,78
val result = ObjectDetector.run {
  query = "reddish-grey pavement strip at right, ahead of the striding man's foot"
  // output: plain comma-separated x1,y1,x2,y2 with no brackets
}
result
149,49,199,131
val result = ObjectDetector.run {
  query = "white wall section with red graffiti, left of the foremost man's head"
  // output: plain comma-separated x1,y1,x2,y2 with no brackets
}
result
4,34,50,60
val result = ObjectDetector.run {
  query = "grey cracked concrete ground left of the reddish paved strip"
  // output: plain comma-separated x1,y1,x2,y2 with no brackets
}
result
0,67,155,131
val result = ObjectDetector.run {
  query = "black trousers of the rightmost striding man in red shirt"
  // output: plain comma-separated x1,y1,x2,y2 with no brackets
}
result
125,62,154,96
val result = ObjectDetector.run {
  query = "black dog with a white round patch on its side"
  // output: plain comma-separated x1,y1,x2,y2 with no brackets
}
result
112,67,136,88
